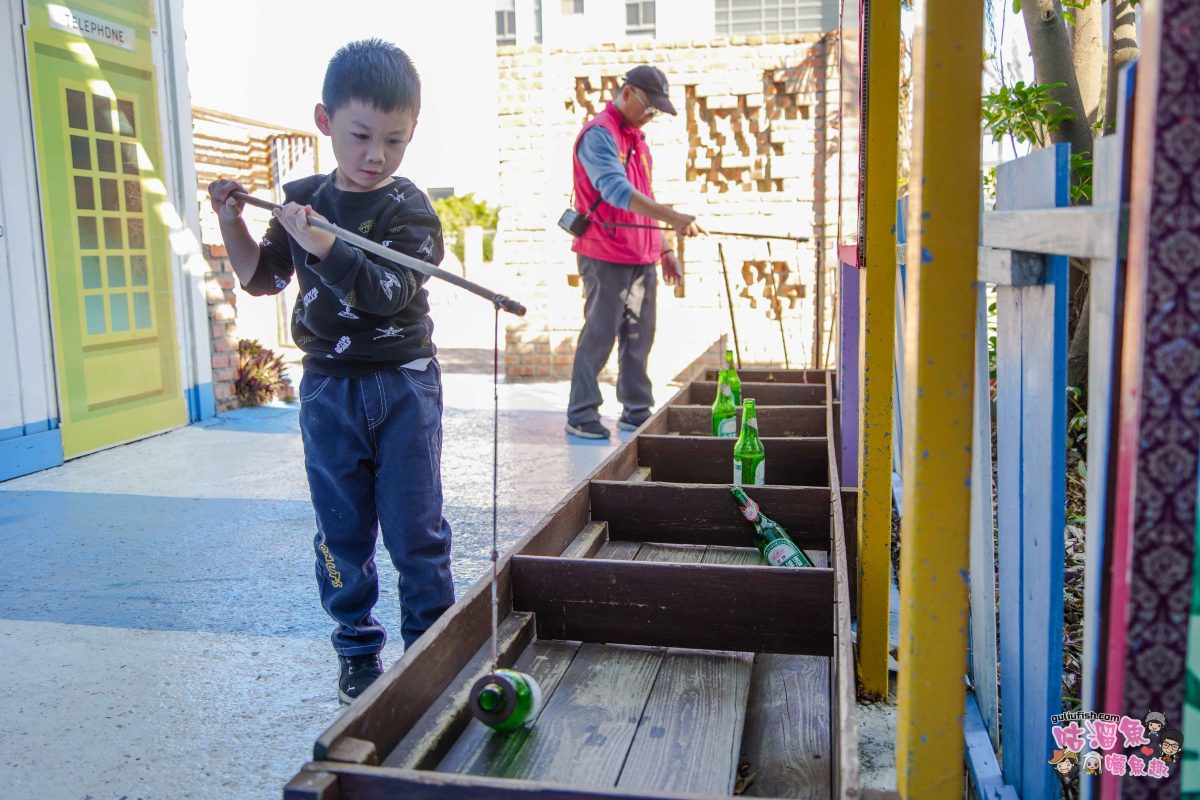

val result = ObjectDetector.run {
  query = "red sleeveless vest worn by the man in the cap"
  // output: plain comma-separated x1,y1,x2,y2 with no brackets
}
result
571,102,662,264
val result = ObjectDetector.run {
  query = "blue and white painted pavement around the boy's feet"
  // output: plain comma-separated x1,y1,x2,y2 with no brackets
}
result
0,359,643,800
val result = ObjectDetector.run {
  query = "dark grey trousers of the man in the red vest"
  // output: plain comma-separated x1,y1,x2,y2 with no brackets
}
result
566,255,658,425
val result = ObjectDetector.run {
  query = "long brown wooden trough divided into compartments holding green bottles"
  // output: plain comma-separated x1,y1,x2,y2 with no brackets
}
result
284,359,858,800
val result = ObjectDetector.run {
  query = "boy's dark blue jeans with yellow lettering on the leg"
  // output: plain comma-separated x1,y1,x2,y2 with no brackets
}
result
300,360,454,656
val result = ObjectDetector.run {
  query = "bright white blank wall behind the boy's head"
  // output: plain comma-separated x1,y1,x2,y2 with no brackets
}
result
184,0,496,198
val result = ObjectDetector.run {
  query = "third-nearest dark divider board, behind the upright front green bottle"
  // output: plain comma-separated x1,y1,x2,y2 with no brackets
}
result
637,435,829,486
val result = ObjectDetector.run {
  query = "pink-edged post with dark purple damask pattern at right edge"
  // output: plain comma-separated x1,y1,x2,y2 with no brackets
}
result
1098,0,1200,799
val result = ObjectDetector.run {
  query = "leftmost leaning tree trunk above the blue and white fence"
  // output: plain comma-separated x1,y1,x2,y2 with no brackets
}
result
1021,0,1094,160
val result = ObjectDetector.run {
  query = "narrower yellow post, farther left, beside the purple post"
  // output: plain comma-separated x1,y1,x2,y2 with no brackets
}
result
858,1,900,699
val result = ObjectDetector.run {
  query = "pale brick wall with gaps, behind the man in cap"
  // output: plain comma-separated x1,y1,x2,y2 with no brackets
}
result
487,35,838,380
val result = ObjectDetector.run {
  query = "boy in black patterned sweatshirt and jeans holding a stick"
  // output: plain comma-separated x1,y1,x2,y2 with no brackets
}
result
209,40,454,704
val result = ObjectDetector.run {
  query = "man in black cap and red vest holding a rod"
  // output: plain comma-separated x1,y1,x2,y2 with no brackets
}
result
566,65,704,439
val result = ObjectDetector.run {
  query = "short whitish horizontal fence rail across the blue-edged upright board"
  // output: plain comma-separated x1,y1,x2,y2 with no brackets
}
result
982,204,1121,258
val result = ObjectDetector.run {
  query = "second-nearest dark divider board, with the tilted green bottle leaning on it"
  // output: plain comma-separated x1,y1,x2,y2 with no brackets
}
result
590,481,829,549
